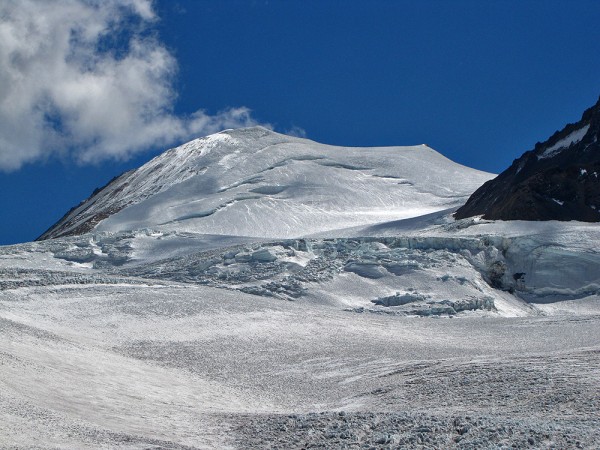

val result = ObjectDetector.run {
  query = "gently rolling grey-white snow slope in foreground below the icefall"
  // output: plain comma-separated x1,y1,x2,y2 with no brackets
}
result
0,280,600,450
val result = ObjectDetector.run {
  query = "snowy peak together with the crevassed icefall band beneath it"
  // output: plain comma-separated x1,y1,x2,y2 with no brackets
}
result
27,127,600,316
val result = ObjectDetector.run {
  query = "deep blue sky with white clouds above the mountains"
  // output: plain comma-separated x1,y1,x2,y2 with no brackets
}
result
0,0,600,244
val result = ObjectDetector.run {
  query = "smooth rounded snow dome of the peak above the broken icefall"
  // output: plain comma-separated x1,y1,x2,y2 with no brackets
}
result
42,127,492,239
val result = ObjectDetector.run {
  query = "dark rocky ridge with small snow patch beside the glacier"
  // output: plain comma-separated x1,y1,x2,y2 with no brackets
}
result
455,100,600,222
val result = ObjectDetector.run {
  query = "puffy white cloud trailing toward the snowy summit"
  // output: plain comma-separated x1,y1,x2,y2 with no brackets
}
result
0,0,264,170
